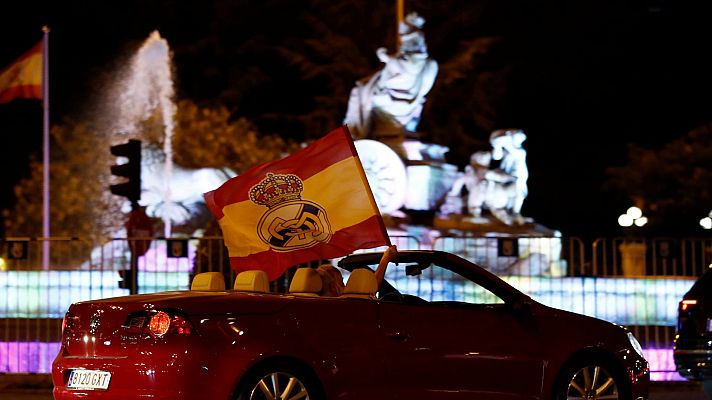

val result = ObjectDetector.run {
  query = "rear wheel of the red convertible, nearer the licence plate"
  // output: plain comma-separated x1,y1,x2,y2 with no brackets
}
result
236,362,323,400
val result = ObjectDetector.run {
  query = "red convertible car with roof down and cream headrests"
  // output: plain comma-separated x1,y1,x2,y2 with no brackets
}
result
52,251,649,400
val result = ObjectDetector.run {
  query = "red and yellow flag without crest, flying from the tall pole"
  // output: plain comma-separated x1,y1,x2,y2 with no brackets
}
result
0,41,42,103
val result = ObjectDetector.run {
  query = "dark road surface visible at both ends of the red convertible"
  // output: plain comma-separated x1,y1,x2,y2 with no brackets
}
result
0,382,710,400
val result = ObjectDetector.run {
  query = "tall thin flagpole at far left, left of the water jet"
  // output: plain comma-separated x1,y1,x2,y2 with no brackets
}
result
42,25,50,270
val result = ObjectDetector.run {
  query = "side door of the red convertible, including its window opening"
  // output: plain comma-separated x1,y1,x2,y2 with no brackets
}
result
379,267,544,399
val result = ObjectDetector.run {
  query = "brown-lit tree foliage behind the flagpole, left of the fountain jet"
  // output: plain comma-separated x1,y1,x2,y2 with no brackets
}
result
3,121,122,241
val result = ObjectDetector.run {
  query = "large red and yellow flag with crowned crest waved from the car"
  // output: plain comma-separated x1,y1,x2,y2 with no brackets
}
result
204,125,390,280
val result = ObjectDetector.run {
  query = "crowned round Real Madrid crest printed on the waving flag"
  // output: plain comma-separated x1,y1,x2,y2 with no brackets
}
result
249,173,331,251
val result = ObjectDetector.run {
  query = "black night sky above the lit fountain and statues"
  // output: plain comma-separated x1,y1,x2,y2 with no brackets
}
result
0,0,712,236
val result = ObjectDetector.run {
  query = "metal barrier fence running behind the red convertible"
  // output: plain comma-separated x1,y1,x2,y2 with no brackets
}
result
0,236,700,379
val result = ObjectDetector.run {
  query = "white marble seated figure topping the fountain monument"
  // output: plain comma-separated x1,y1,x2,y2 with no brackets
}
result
344,13,438,139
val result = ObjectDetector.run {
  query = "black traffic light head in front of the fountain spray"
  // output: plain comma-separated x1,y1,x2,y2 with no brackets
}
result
109,139,141,207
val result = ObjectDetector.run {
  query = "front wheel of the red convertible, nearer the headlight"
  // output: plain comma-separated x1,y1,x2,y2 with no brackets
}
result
553,357,628,400
